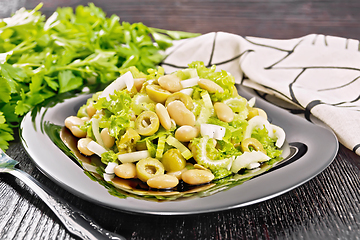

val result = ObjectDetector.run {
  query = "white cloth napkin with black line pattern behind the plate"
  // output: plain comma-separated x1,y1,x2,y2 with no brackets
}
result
162,32,360,155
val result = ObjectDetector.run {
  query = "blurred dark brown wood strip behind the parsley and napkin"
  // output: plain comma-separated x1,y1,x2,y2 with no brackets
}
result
27,0,360,39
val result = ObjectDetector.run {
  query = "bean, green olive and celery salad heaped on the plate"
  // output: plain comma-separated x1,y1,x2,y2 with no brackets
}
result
65,61,285,200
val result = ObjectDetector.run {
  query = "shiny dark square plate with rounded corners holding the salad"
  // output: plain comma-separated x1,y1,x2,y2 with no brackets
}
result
21,88,338,215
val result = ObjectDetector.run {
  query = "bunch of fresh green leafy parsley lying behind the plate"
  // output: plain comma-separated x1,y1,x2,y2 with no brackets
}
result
0,3,198,150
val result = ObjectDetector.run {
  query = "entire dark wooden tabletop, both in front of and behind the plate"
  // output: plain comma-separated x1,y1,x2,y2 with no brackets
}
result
0,0,360,239
